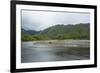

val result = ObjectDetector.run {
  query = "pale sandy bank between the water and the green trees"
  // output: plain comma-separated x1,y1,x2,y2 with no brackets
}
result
23,40,90,47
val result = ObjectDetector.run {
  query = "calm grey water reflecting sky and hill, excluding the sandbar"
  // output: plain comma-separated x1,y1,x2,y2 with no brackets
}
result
21,42,90,63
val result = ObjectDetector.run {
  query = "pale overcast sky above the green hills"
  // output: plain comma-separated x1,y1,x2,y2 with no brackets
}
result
21,10,90,31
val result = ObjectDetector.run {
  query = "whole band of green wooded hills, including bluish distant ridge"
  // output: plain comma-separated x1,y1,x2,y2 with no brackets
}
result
21,23,90,41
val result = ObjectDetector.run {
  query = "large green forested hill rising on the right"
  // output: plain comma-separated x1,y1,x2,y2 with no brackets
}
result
39,23,90,39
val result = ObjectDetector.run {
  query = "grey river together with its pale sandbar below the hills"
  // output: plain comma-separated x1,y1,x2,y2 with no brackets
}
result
21,40,90,63
